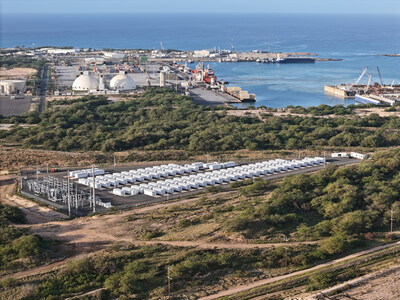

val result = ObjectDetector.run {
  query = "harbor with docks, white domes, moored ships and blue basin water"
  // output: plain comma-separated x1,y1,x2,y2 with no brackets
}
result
3,44,398,108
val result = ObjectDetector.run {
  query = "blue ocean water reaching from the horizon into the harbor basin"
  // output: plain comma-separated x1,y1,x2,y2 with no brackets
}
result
0,13,400,107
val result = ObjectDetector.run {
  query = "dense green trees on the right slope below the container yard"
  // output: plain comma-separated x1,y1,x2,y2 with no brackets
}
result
227,149,400,245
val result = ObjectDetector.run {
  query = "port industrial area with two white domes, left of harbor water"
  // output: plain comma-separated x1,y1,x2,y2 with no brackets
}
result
52,56,256,103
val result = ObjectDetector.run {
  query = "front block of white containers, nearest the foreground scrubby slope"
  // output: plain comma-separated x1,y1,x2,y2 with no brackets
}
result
113,157,325,196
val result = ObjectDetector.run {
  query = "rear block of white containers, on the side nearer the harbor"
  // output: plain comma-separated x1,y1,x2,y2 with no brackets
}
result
78,162,235,188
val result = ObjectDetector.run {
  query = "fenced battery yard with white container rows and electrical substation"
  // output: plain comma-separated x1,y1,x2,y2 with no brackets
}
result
21,157,326,215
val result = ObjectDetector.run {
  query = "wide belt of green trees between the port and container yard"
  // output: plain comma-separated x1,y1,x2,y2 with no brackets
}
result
0,89,400,153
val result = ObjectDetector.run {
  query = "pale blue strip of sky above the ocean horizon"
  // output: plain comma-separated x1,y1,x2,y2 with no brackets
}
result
0,0,400,14
